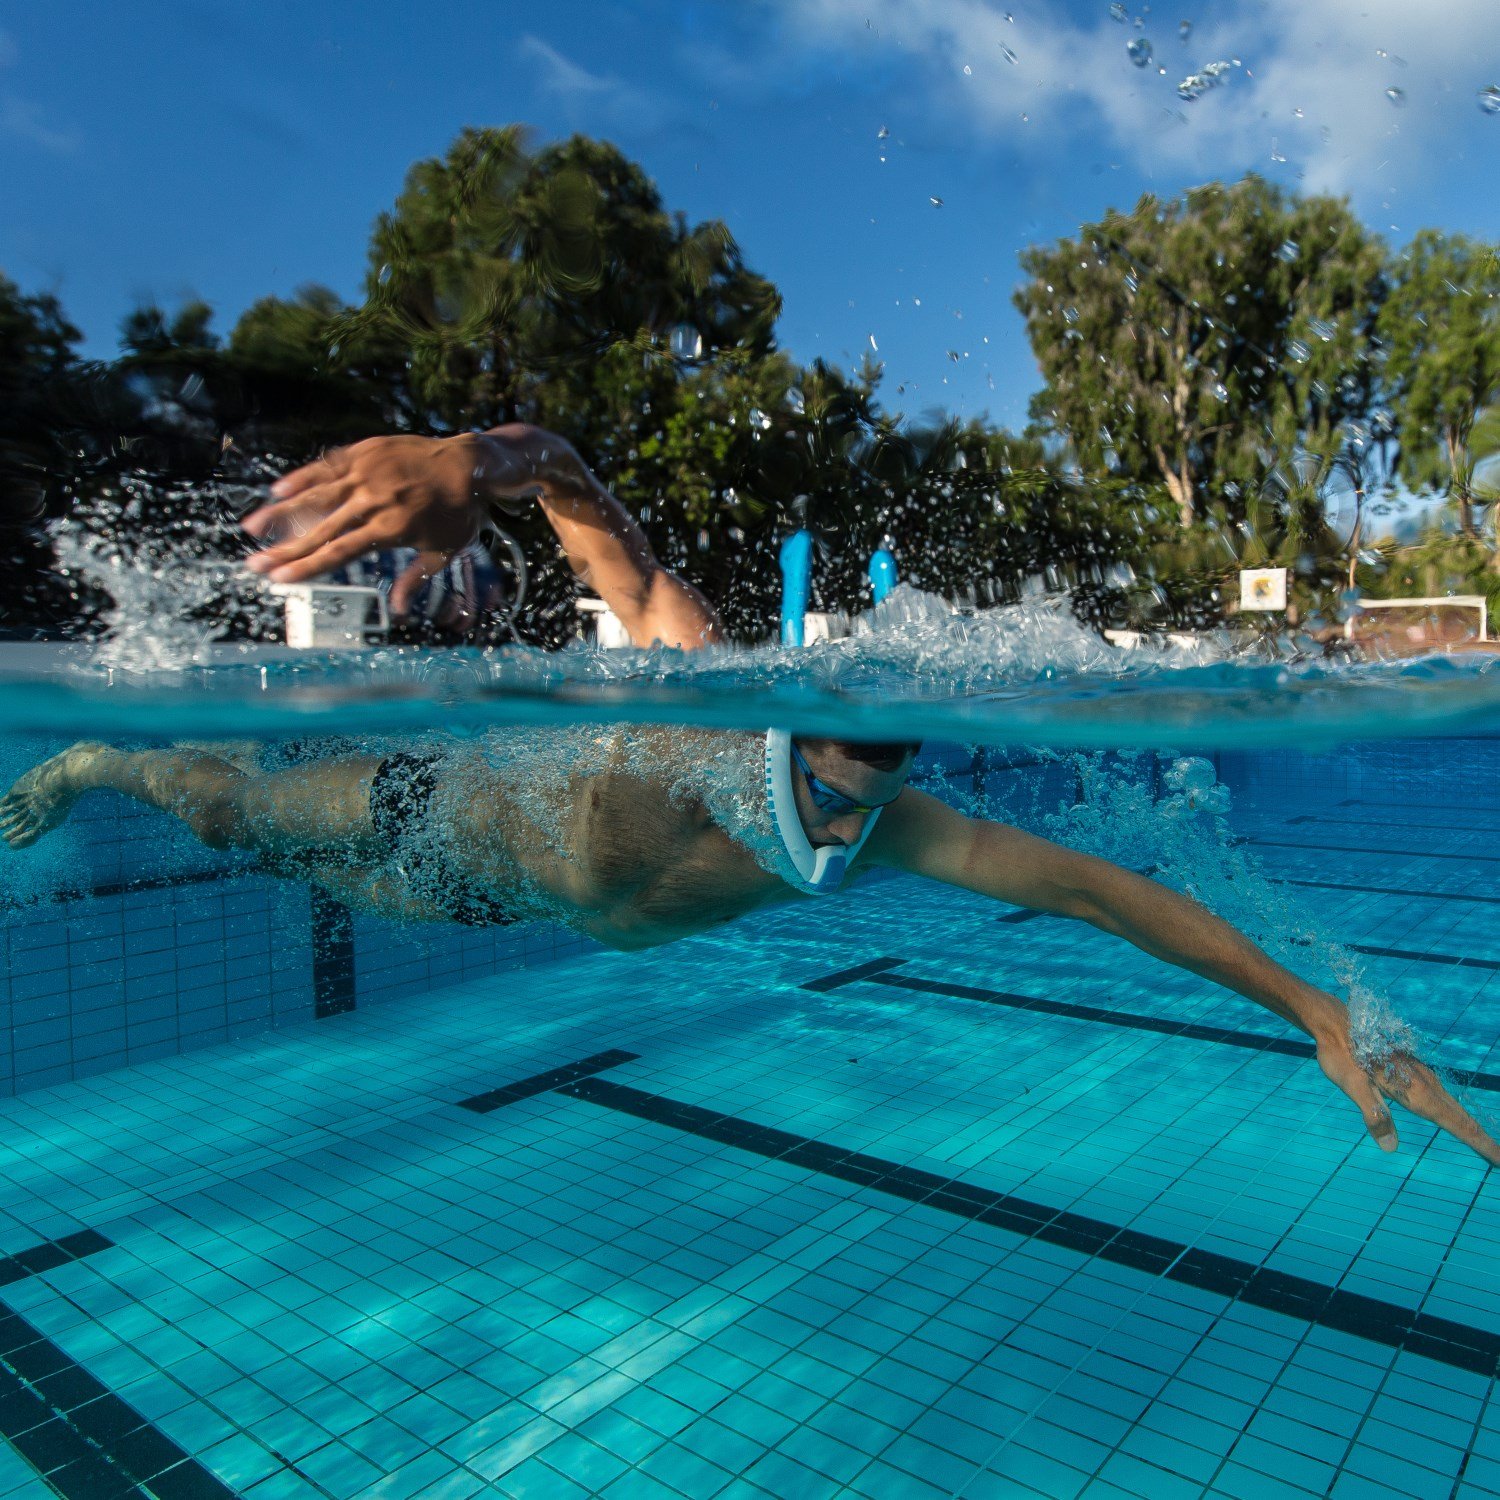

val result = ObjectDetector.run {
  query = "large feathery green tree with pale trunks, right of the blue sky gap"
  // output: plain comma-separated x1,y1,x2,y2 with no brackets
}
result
1016,176,1385,525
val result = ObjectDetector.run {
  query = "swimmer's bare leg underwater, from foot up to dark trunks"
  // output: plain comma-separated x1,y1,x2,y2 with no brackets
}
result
0,741,384,861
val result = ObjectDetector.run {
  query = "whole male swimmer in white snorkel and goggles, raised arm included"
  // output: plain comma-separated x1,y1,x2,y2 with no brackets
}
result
0,425,1500,1164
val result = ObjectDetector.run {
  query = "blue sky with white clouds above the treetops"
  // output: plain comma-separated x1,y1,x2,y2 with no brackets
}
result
0,0,1500,438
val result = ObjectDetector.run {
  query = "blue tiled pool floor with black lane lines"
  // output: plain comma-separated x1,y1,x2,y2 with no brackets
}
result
0,810,1500,1500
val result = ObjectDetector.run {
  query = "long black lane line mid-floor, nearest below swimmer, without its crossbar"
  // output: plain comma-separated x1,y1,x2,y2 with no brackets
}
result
558,1079,1500,1379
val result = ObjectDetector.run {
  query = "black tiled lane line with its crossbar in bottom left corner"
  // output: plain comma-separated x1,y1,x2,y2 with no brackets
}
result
0,1229,234,1500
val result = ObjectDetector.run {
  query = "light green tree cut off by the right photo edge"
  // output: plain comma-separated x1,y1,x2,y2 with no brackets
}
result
1379,230,1500,540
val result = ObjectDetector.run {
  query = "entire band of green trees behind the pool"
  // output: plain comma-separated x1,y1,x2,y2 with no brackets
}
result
0,128,1500,641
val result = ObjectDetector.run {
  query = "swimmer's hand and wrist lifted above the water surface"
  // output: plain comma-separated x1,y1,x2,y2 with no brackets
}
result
242,423,582,614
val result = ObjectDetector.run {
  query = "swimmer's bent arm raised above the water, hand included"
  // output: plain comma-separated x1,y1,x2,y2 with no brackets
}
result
243,423,722,650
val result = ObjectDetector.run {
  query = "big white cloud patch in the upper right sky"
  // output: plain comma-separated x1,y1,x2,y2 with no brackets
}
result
767,0,1500,198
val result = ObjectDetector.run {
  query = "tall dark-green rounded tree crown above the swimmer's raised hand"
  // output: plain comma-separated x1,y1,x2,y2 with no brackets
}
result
344,126,779,431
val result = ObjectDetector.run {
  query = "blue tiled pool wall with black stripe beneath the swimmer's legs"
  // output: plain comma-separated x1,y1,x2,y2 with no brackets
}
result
0,774,594,1095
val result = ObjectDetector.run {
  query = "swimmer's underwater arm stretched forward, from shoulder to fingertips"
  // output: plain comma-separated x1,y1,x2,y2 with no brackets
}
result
870,789,1500,1166
